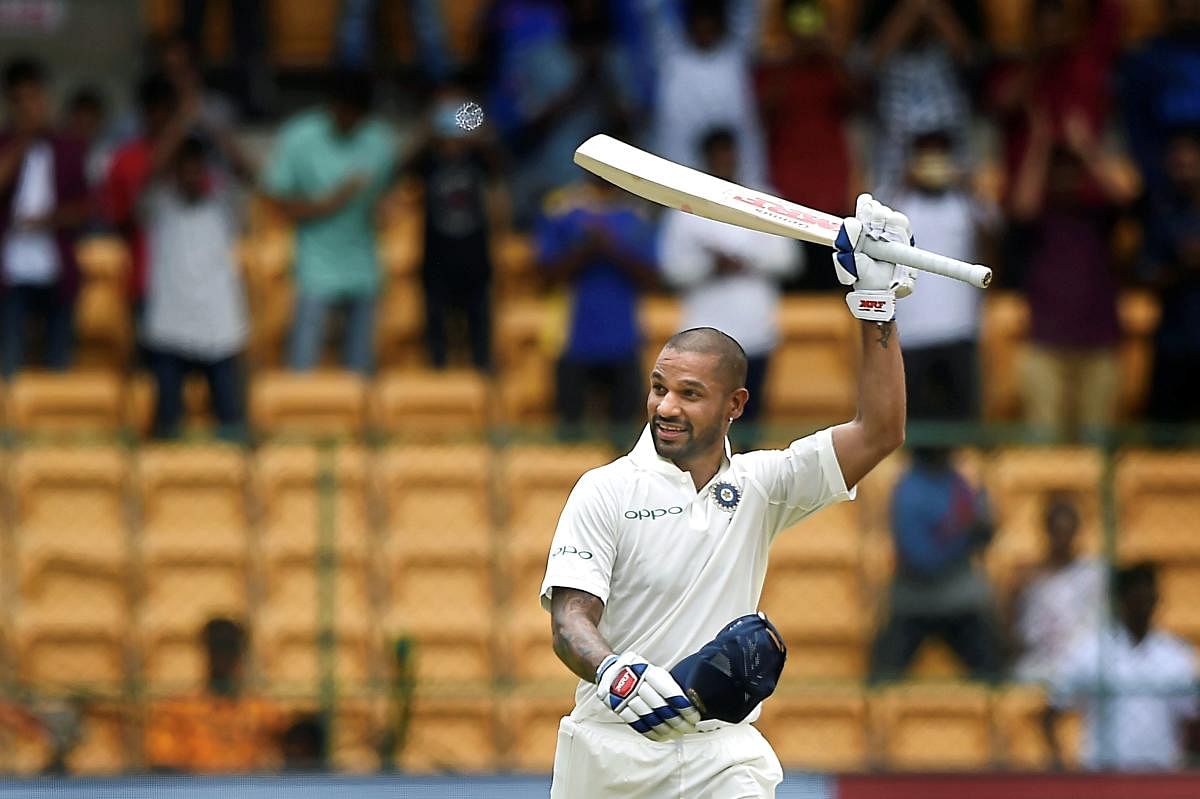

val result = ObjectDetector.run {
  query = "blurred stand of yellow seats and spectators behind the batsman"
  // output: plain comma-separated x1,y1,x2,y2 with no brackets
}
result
0,0,1200,797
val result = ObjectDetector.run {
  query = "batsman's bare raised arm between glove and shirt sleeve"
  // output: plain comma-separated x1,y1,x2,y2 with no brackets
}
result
833,322,905,487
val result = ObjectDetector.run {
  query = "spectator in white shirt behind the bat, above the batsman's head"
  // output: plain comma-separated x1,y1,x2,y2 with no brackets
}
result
660,128,802,426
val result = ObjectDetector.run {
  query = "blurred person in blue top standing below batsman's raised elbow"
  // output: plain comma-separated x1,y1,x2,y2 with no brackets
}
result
870,447,1000,681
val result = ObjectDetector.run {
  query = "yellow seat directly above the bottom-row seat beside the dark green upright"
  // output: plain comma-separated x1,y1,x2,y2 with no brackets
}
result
384,559,497,684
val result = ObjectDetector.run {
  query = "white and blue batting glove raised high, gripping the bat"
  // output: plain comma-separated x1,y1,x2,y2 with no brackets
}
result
833,194,917,322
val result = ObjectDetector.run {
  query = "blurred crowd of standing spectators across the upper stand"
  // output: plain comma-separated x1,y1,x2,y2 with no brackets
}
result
0,0,1200,435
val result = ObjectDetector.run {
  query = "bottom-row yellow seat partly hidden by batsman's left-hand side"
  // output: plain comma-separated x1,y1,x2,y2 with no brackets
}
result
500,683,575,774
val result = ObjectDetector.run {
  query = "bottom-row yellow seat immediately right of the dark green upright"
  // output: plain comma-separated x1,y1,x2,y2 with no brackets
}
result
396,696,499,774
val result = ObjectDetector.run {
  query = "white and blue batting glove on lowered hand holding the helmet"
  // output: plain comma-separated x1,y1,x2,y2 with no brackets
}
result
596,651,700,741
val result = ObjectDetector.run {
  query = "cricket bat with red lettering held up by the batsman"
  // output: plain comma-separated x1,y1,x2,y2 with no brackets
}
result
575,133,991,288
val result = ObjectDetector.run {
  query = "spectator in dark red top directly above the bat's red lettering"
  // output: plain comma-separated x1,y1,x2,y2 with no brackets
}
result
756,0,859,286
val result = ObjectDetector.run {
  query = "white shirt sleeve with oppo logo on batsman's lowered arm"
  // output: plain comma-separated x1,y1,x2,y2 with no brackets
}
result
541,471,617,611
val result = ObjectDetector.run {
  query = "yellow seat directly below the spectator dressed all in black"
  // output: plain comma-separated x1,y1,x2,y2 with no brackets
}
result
372,370,490,438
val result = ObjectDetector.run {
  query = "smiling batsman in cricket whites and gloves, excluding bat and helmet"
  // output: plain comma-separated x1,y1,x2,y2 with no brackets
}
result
541,194,912,799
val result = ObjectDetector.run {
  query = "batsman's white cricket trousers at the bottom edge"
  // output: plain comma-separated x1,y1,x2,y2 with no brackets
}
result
550,716,784,799
